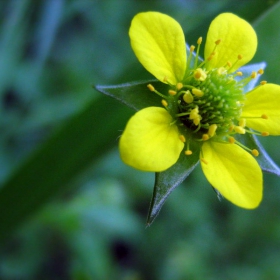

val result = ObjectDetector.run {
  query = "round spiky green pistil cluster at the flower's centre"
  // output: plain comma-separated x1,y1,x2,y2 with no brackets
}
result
177,68,244,137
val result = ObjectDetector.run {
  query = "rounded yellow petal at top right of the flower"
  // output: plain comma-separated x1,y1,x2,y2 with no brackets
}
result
204,13,258,72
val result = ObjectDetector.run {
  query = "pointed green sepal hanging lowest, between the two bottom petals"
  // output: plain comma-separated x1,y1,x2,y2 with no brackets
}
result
147,143,200,226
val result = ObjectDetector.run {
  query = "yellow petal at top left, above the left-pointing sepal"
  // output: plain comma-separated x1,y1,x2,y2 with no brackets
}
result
129,12,187,85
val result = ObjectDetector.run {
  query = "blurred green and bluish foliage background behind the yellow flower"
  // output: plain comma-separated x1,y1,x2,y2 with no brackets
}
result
0,0,280,280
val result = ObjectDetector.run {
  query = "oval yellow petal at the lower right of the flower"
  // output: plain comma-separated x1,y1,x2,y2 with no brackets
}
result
201,141,263,209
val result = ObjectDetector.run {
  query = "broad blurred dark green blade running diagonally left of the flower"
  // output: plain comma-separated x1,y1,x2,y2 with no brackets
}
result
0,96,131,241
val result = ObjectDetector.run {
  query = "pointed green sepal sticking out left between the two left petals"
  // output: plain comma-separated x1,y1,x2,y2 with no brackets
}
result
95,80,169,111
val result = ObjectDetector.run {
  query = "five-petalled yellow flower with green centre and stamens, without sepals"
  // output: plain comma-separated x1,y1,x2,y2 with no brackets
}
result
120,12,280,208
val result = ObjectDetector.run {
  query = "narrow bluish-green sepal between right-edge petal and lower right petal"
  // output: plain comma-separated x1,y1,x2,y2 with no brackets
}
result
236,133,280,176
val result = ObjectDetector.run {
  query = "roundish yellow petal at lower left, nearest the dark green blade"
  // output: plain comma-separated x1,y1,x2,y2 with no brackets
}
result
120,107,184,172
